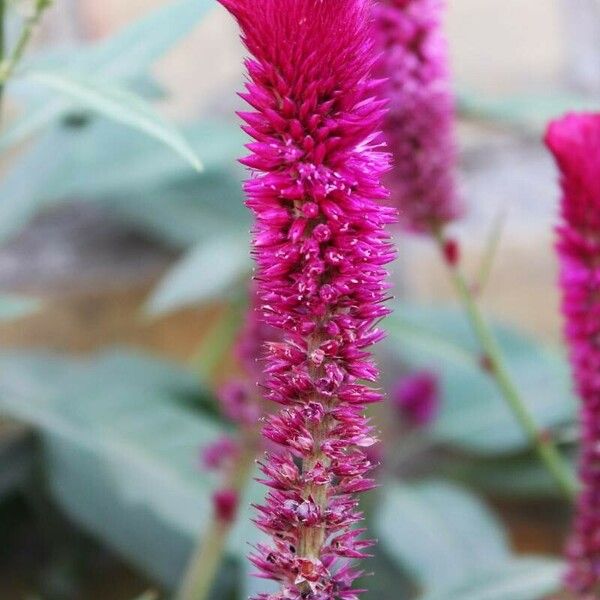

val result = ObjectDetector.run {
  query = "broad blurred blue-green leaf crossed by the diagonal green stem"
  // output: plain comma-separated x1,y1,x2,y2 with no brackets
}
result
387,306,577,455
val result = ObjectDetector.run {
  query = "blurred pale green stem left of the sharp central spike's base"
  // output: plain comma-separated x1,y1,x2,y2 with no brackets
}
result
176,434,257,600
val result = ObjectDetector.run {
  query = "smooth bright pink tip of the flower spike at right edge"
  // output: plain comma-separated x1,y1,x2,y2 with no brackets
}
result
545,113,600,195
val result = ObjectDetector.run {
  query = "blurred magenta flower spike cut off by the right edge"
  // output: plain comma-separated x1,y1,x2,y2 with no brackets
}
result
546,114,600,600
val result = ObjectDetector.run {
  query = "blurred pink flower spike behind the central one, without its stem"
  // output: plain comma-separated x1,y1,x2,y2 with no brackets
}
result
374,0,461,233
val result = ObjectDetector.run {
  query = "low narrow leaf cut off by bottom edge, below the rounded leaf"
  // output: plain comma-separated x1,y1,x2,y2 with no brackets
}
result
421,558,564,600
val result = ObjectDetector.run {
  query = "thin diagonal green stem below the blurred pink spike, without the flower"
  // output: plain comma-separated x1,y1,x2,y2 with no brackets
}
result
434,231,577,500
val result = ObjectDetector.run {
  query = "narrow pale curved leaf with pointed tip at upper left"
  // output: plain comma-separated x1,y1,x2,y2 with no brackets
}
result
26,71,202,171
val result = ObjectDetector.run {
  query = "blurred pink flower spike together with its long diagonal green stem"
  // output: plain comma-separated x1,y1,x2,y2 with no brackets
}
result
374,0,576,500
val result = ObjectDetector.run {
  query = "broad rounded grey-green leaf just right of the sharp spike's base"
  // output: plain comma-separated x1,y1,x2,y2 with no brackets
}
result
374,481,510,590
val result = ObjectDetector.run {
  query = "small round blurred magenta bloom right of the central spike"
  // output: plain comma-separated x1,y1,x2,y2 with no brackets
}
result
391,371,440,427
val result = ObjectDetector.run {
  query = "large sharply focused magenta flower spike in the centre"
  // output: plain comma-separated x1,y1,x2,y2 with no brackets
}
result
221,0,396,600
